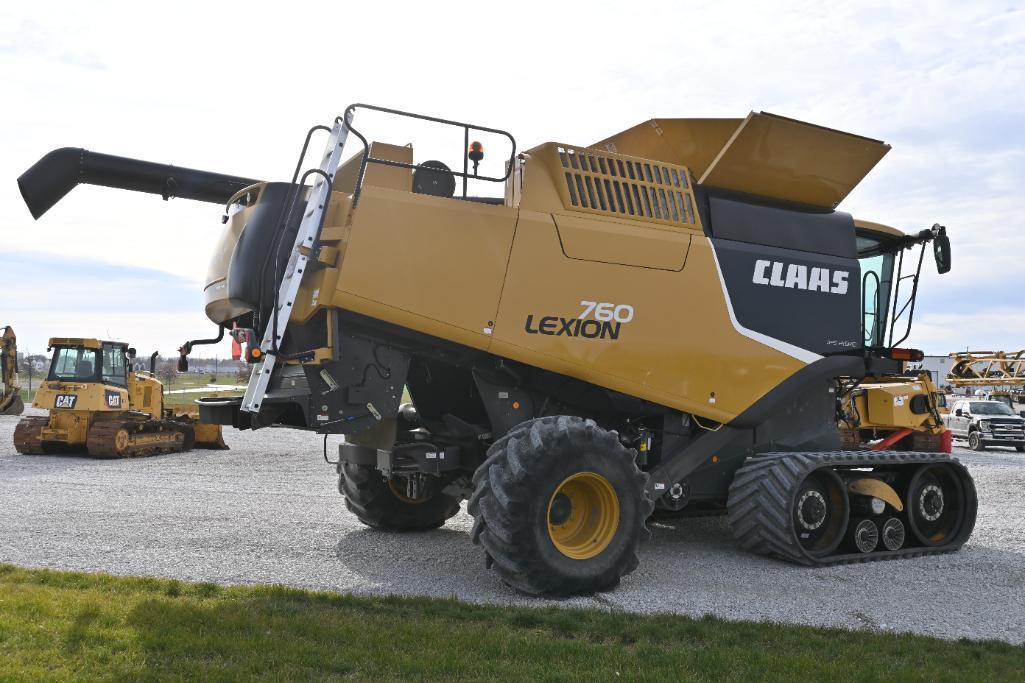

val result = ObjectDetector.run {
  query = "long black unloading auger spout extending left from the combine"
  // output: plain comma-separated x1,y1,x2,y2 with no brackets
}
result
17,147,260,218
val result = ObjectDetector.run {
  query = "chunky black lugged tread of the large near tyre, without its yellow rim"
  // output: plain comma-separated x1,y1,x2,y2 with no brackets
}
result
466,415,655,595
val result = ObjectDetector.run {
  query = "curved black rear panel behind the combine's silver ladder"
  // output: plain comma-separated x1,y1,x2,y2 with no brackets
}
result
228,183,305,319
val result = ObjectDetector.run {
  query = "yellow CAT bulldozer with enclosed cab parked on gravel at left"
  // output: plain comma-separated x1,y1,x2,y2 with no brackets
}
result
14,337,228,457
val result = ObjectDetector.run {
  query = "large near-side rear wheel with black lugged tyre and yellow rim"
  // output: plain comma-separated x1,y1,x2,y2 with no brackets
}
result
468,416,654,595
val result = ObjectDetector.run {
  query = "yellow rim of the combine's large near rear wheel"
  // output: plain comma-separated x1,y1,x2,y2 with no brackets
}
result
548,472,619,560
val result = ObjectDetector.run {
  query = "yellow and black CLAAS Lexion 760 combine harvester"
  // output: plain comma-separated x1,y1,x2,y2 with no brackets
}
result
19,105,977,594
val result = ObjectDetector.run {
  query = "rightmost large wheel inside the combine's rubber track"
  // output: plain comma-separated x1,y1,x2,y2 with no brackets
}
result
906,464,974,548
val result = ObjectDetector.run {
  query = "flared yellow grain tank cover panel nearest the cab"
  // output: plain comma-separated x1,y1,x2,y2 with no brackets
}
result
699,113,890,209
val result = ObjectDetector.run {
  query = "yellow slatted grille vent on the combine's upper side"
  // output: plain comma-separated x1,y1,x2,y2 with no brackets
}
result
555,146,698,226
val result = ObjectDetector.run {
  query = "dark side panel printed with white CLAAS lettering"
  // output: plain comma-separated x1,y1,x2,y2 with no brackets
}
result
712,234,863,355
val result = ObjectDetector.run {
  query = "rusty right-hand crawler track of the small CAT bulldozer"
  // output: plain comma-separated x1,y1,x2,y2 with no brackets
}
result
86,419,196,457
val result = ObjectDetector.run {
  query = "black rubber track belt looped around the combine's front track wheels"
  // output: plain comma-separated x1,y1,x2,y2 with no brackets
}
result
727,451,978,566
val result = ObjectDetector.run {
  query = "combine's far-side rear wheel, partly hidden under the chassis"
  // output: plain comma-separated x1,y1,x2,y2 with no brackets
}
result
338,463,459,531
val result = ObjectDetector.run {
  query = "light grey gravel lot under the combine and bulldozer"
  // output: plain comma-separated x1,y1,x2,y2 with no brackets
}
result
0,406,1025,643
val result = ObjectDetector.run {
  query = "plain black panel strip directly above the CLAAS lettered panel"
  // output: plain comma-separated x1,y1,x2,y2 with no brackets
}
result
708,196,858,258
